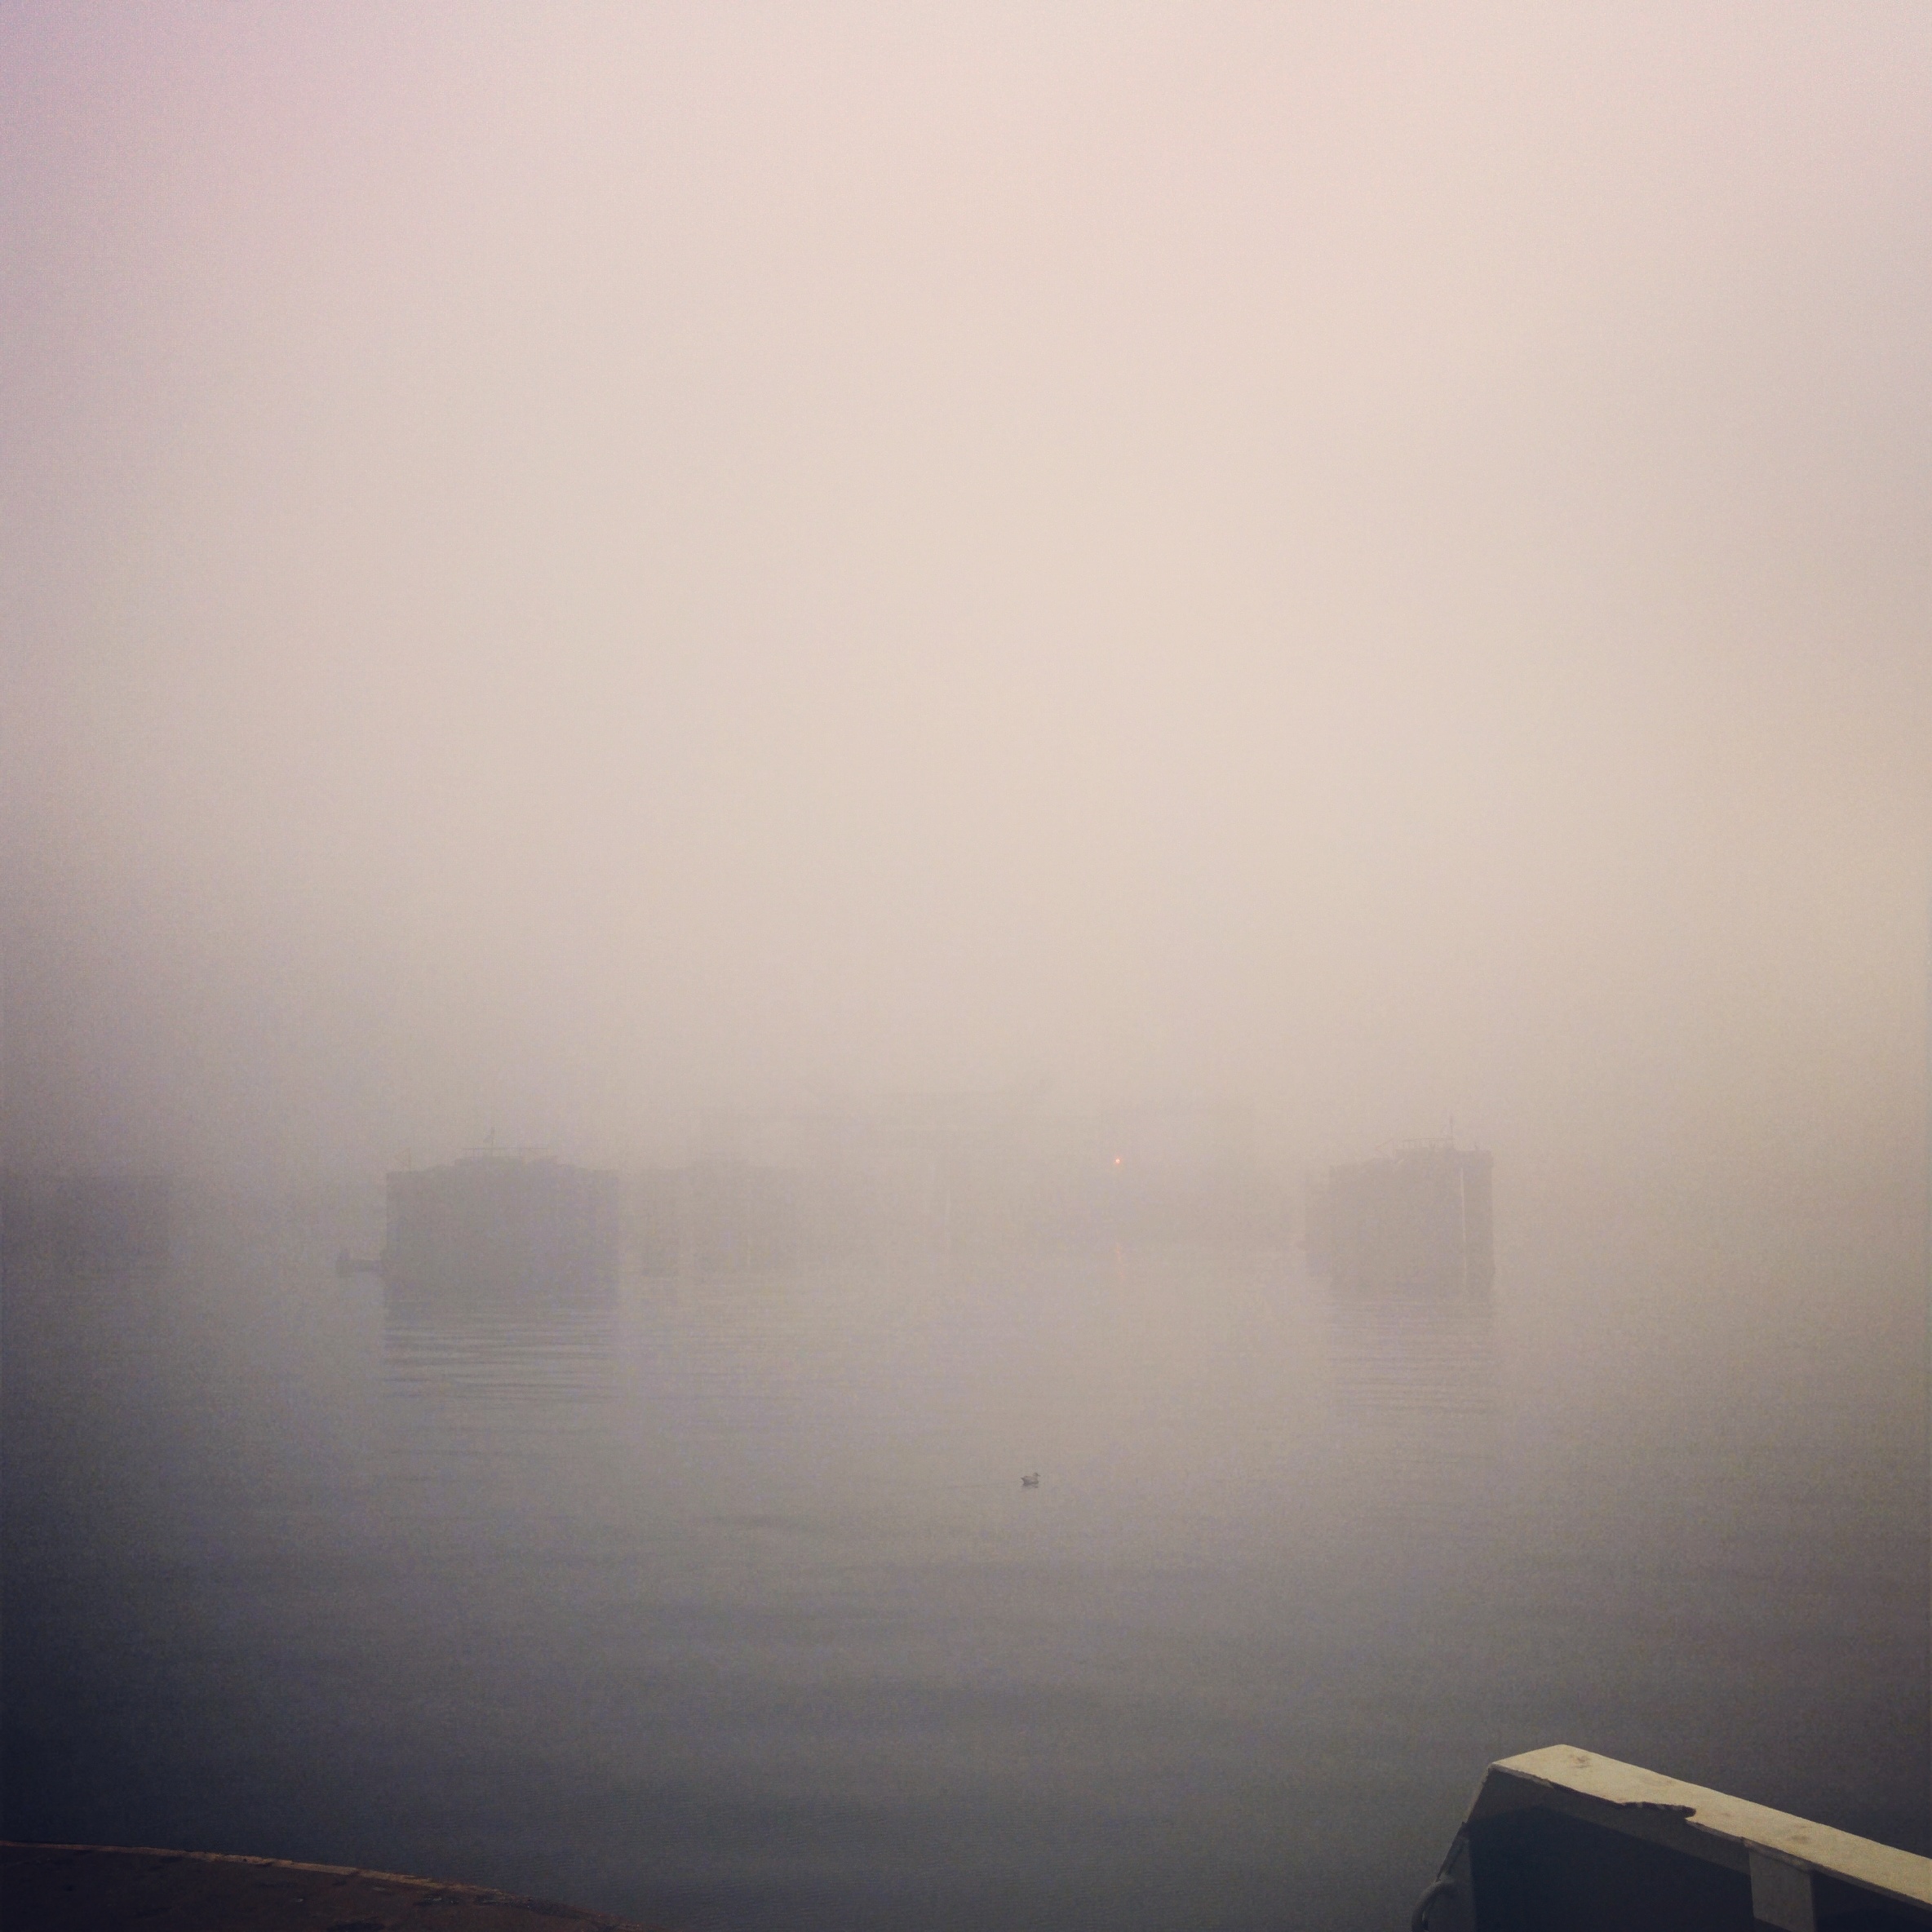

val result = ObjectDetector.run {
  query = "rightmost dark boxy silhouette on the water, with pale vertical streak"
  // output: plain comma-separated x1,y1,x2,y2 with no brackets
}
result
1306,1141,1496,1291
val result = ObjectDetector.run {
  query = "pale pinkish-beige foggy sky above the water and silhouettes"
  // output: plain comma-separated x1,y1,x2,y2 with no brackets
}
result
0,0,1932,1169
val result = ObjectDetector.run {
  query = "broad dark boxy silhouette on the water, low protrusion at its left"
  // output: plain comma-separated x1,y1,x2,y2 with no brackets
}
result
383,1154,620,1296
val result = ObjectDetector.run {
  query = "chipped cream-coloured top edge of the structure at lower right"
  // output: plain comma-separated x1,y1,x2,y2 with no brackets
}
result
1469,1744,1932,1907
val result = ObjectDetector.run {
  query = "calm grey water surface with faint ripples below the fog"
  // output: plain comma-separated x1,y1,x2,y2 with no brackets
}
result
4,1203,1928,1932
